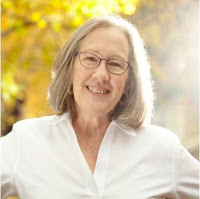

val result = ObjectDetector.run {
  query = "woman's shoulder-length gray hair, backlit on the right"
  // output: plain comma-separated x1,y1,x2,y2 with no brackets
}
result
48,15,154,128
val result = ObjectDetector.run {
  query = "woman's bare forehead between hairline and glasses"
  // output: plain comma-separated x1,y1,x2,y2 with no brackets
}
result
80,27,129,60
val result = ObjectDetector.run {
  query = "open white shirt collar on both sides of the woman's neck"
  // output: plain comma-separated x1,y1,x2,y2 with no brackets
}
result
59,112,137,137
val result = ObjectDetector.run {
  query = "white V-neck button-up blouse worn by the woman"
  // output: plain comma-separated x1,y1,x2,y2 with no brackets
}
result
1,113,199,199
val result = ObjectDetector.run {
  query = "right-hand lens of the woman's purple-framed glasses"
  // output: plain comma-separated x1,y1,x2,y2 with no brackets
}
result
107,60,128,74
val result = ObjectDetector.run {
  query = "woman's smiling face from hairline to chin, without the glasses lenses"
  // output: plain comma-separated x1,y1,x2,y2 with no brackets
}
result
73,27,129,119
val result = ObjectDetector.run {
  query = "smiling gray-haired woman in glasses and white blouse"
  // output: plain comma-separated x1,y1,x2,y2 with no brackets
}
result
1,16,198,199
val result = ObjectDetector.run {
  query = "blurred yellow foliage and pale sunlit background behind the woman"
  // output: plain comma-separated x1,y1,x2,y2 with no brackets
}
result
1,0,199,159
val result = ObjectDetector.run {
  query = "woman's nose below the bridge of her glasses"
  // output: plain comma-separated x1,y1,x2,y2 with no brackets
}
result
93,60,110,84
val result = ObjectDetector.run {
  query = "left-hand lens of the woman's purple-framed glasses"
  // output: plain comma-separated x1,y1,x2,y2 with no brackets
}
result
80,53,100,68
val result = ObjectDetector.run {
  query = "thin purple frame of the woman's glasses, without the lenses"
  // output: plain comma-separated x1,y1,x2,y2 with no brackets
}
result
76,52,131,75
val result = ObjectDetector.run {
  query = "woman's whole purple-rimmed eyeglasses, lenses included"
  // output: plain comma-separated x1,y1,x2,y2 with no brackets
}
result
77,52,130,75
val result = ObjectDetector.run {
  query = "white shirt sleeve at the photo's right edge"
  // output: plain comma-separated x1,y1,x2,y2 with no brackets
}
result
174,137,199,199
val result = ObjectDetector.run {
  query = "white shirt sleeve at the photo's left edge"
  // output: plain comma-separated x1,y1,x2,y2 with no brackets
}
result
0,125,18,199
